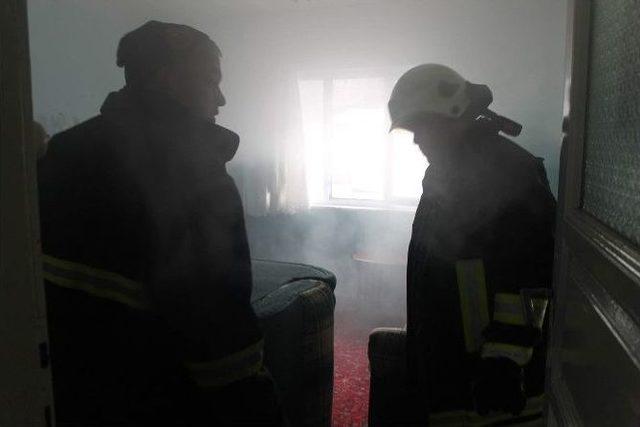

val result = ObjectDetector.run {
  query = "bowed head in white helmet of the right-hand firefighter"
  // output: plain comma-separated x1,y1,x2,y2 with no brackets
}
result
389,64,491,163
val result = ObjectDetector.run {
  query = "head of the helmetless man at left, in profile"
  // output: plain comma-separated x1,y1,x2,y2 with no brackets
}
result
118,21,226,120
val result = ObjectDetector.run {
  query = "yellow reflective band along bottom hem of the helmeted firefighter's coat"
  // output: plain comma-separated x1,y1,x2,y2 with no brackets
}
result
429,394,545,427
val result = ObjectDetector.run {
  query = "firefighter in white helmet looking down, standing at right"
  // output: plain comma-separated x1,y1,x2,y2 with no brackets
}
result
389,64,555,425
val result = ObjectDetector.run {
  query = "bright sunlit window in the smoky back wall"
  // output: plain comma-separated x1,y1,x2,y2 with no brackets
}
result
298,77,428,207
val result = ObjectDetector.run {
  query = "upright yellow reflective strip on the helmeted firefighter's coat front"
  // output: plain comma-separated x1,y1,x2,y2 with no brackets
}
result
456,259,489,353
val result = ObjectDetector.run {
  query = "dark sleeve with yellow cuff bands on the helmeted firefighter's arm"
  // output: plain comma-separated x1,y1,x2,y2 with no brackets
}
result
480,168,555,366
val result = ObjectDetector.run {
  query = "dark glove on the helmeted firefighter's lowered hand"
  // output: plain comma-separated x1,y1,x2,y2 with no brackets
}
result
473,357,527,416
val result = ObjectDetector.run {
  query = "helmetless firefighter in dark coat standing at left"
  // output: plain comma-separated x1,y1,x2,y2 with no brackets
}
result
39,21,280,426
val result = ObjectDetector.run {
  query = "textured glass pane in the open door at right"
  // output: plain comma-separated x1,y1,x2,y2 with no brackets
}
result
583,0,640,245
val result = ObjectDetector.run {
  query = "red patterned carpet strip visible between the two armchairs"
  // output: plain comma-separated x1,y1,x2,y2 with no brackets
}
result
333,325,369,427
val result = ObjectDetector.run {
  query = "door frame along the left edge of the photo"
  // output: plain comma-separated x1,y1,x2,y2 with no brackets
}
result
0,0,55,427
